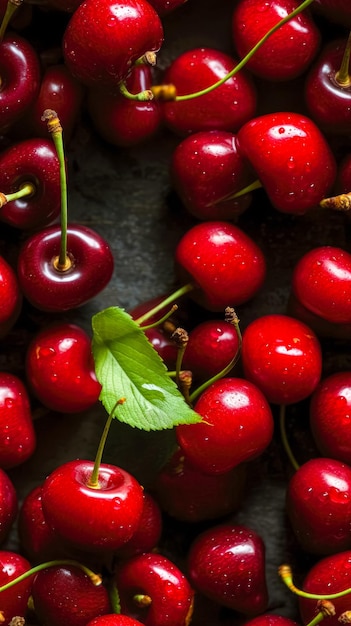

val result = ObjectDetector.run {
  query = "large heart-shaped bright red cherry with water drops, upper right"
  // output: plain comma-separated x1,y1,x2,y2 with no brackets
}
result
237,111,336,215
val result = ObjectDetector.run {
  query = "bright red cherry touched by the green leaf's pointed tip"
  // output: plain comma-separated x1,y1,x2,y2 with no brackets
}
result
176,378,274,474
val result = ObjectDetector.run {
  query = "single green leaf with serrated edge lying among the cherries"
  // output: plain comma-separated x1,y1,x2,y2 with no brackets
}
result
92,307,201,430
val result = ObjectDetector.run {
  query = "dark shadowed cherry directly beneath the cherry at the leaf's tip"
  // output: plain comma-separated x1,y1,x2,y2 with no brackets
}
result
152,449,246,523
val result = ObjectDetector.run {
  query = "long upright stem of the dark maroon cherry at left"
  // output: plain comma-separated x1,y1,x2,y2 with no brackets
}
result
41,109,72,272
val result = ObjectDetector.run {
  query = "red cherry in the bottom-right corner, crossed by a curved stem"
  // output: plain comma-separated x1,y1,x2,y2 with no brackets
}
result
299,550,351,626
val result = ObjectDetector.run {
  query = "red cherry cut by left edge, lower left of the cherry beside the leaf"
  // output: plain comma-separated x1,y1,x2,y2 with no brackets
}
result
0,372,36,470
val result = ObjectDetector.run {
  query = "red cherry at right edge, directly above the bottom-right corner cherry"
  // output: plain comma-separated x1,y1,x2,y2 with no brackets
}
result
286,457,351,556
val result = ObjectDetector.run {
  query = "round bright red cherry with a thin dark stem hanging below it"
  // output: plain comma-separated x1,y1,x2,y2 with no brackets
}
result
242,314,322,404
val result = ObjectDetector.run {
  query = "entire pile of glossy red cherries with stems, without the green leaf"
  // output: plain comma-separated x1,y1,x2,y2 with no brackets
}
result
0,0,351,626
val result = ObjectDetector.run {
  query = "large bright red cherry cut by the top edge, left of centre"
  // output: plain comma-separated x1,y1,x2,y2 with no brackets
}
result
63,0,163,91
